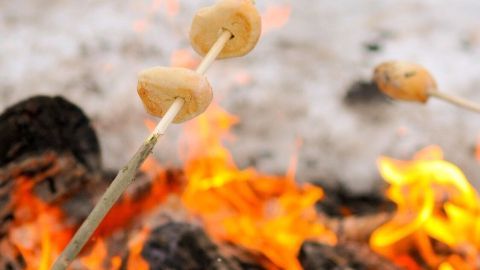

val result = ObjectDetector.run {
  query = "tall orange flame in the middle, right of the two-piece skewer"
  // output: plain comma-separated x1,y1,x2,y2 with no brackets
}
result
178,104,336,269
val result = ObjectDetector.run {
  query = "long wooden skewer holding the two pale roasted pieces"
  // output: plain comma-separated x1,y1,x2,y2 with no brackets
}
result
51,30,232,270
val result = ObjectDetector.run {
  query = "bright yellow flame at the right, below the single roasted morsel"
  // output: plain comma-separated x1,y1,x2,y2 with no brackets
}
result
370,146,480,269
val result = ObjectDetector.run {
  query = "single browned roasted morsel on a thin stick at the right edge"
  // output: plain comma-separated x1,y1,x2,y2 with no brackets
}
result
373,61,480,113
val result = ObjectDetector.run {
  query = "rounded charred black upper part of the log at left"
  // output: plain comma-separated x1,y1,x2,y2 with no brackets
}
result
0,96,101,170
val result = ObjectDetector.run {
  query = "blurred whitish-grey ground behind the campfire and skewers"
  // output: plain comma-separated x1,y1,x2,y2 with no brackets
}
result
0,0,480,192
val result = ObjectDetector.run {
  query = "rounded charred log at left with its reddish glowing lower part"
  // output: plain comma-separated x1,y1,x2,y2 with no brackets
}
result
0,96,101,238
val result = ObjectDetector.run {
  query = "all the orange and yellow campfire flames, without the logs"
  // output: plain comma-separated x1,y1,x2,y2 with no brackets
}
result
8,104,480,270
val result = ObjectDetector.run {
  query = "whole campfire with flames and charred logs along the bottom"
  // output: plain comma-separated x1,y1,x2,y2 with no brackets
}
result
0,94,480,269
